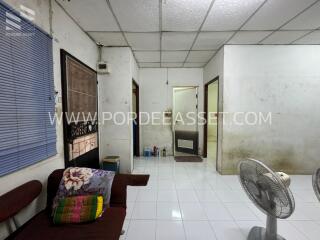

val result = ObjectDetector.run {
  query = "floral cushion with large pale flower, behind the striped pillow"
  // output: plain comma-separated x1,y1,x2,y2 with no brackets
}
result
52,167,115,212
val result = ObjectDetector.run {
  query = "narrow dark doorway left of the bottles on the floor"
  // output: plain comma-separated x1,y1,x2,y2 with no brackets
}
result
132,80,140,157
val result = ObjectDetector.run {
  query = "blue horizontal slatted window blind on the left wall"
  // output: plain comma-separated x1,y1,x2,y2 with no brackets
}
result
0,1,56,176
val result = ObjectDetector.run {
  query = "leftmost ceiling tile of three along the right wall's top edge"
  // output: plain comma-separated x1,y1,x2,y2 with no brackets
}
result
228,31,272,44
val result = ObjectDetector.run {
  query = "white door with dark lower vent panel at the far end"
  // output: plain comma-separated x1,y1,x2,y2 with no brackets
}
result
172,87,199,156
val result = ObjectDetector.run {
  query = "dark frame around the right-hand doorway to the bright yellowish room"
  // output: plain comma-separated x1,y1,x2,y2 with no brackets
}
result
203,76,220,162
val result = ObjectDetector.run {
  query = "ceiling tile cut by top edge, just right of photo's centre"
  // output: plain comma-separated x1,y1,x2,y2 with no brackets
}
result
162,0,211,31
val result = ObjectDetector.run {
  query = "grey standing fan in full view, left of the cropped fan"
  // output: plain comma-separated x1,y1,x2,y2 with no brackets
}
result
239,159,295,240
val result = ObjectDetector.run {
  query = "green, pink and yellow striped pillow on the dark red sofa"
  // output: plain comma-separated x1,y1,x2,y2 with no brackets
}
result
53,195,103,224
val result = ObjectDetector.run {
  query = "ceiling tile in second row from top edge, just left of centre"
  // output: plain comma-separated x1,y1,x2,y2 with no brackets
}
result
125,33,160,50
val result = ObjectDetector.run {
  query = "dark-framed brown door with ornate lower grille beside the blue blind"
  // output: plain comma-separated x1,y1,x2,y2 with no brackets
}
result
61,50,99,168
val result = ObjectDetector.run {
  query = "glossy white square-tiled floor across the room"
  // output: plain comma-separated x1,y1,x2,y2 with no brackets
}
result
121,157,320,240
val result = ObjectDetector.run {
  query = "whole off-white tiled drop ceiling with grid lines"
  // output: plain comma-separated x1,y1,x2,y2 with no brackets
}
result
56,0,320,67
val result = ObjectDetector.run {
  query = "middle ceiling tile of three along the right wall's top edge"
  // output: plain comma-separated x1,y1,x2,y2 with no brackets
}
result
262,31,308,44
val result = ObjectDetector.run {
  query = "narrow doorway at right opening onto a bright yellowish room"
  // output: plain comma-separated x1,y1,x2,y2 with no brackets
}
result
203,77,220,166
